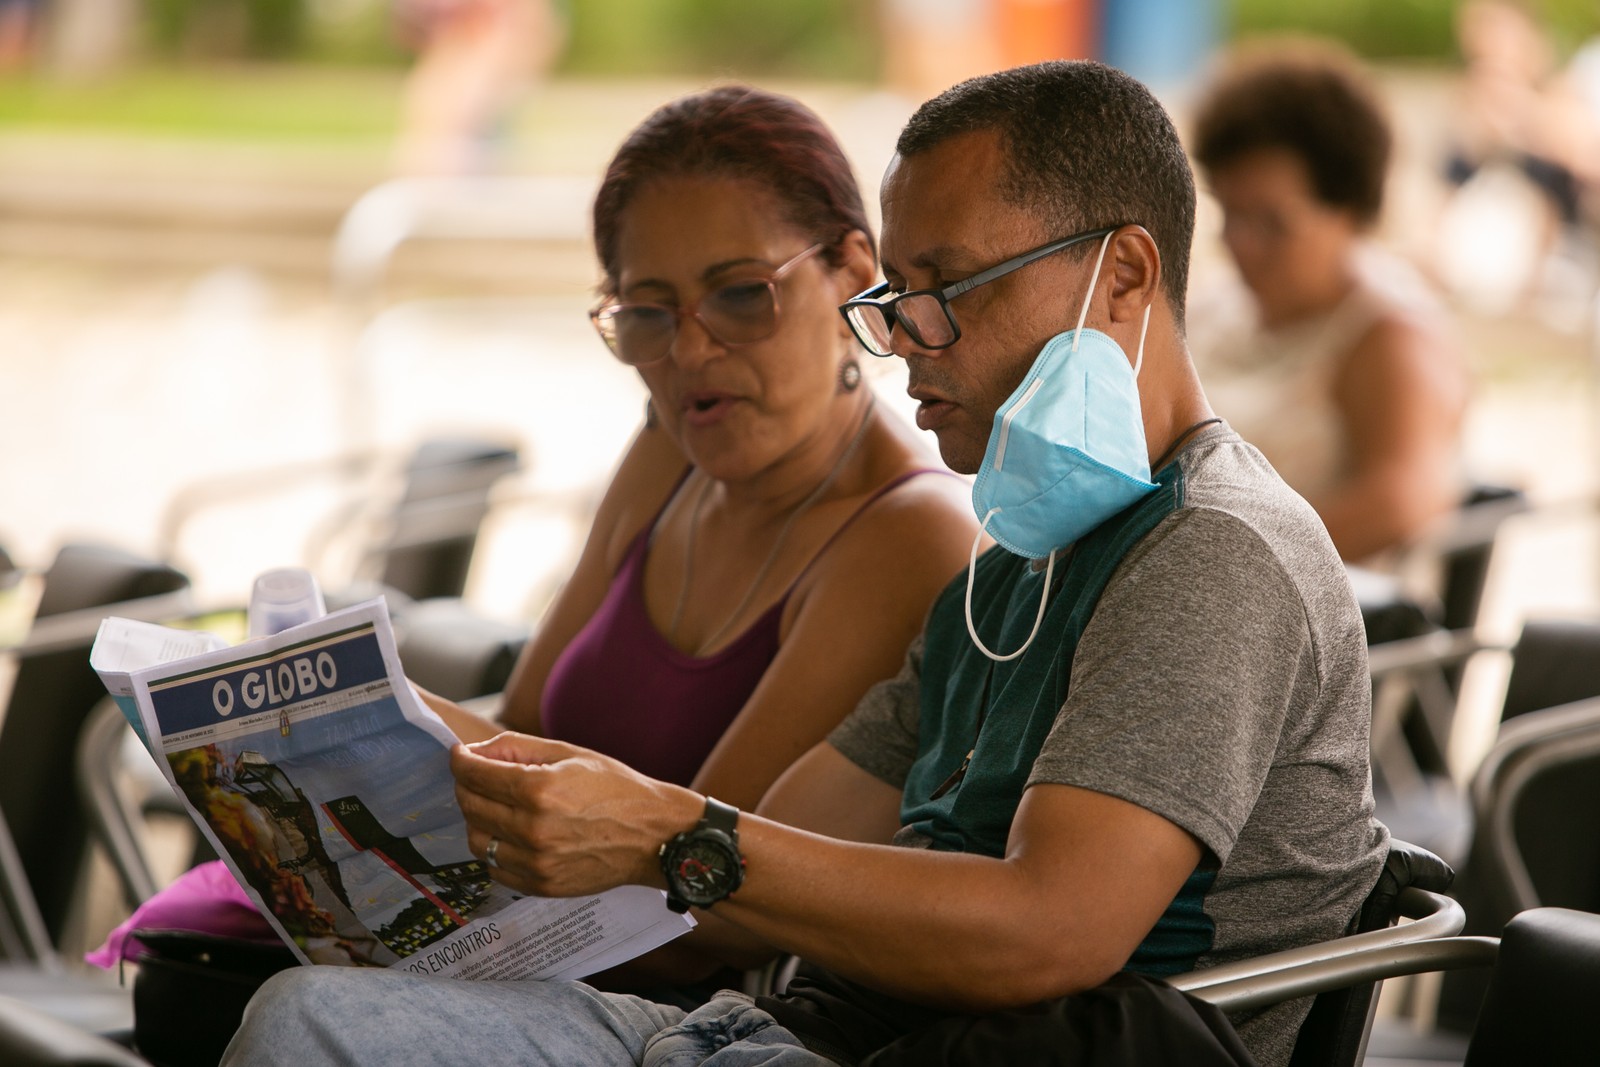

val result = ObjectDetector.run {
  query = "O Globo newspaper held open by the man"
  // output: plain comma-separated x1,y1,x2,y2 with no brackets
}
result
91,600,694,979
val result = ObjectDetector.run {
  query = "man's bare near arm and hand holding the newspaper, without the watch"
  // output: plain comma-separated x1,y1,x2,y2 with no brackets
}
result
453,734,1200,1011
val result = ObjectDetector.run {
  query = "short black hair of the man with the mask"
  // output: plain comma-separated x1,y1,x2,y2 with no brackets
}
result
894,59,1195,330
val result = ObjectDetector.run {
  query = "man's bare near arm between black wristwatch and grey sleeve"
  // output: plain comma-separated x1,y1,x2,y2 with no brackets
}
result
715,785,1202,1011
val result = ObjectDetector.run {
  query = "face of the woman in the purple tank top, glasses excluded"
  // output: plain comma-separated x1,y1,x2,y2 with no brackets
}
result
616,176,870,480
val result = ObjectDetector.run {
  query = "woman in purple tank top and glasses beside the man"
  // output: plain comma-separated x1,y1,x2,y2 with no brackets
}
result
430,86,974,825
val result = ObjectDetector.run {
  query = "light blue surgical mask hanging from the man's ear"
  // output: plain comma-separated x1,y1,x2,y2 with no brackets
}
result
966,234,1157,662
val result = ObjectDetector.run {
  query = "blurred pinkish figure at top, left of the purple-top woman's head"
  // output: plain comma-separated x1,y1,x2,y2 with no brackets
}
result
395,0,566,176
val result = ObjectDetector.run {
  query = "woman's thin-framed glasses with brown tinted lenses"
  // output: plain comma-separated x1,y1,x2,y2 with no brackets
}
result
589,243,822,366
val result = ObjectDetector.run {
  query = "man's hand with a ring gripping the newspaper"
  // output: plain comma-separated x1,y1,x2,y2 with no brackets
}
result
450,733,706,896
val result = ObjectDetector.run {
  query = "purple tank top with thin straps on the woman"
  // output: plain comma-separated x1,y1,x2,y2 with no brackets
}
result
542,469,942,785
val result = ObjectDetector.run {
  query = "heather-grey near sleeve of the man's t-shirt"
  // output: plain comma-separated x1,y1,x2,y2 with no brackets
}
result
1029,509,1315,861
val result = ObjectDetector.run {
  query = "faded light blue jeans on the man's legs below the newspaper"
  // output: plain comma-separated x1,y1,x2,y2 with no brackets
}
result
222,966,832,1067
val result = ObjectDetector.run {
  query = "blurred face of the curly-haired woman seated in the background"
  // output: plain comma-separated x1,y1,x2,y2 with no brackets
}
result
1210,149,1357,323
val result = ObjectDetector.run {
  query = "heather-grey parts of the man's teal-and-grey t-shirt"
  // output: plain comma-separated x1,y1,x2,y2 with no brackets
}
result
830,427,1387,1065
